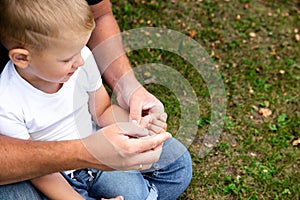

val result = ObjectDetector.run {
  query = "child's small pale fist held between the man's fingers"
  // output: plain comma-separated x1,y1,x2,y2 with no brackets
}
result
140,113,167,135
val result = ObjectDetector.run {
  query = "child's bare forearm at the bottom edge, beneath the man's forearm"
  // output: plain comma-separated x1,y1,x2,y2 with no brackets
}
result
31,172,84,200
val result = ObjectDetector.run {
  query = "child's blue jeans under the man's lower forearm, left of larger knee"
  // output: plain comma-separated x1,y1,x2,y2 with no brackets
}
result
59,169,157,200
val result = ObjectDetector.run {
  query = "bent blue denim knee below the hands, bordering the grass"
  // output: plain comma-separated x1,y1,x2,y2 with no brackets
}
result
142,138,192,200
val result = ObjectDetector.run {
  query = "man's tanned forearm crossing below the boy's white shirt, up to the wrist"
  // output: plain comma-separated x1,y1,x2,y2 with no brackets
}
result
0,135,106,185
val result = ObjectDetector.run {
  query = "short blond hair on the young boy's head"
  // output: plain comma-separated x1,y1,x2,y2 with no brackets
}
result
0,0,95,51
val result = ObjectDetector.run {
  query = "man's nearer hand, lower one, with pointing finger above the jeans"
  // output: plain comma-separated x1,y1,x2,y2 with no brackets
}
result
83,122,172,170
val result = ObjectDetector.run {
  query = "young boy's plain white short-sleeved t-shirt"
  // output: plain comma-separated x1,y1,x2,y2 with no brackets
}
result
0,47,102,141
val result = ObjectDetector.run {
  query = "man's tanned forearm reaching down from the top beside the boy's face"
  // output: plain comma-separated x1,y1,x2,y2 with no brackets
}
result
88,0,135,89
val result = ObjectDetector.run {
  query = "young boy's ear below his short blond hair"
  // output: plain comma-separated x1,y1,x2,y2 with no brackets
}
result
8,48,30,68
